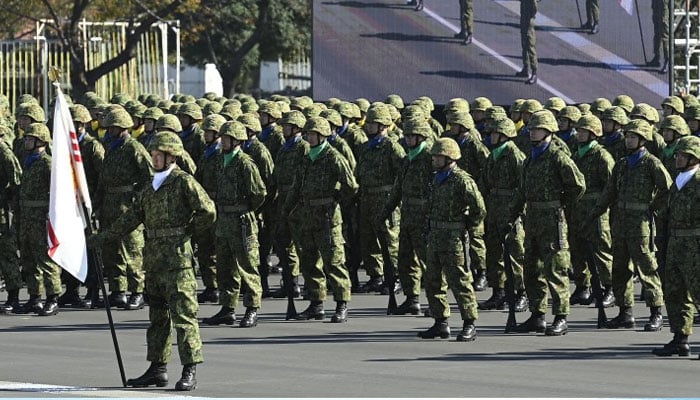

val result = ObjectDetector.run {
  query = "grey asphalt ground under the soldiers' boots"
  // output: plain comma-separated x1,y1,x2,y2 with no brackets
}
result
0,275,700,398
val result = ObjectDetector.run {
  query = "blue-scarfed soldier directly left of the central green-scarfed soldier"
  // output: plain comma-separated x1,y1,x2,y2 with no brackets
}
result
355,104,405,293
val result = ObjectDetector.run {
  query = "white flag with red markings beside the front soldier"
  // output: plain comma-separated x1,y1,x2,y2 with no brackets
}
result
47,84,92,282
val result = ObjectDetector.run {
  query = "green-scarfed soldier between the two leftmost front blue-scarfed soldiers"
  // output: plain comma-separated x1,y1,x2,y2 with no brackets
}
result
479,118,527,312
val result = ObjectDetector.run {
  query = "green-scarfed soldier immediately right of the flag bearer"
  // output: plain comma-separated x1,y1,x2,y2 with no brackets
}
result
203,121,267,328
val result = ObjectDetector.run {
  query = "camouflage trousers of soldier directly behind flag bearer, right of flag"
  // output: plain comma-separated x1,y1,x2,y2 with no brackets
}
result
102,228,145,293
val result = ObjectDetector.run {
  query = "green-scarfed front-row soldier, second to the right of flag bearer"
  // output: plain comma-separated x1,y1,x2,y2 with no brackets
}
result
284,117,357,323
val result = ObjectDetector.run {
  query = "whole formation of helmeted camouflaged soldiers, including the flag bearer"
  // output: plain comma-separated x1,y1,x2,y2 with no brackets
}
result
0,93,700,390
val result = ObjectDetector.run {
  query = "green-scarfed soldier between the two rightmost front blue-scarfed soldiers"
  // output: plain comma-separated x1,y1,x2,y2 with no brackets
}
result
568,114,615,307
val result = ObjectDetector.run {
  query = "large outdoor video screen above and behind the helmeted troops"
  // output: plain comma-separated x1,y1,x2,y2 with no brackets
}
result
313,0,669,107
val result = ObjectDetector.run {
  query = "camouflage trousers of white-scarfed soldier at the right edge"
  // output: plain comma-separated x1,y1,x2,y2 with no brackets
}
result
664,236,700,335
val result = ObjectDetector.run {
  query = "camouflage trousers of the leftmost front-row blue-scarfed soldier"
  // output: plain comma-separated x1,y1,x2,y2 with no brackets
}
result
425,238,479,320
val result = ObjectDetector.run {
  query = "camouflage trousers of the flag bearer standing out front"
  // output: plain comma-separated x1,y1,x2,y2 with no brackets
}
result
146,268,204,365
